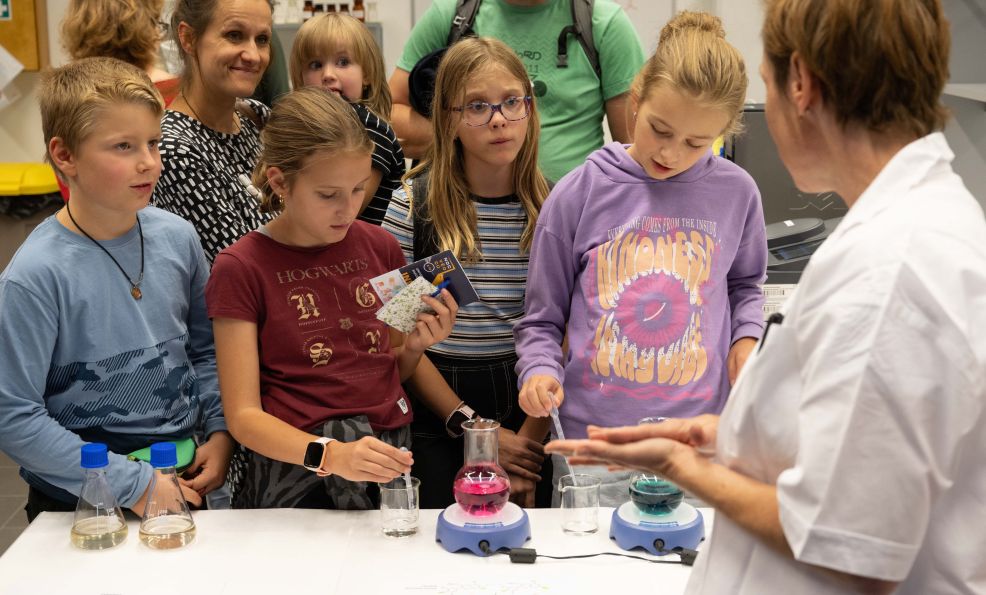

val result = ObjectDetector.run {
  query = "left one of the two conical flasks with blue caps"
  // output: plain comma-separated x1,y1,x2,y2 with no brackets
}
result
71,443,127,550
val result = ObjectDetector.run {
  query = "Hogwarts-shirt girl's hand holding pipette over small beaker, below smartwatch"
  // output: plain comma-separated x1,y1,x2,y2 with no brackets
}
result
327,436,414,483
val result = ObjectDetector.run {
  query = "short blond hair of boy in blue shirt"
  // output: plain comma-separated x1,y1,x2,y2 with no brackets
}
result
38,58,164,174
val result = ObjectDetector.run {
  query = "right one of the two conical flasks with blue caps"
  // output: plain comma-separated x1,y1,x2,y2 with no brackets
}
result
140,442,195,550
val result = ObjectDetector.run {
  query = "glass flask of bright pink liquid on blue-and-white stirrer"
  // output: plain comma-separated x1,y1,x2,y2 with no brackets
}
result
452,417,510,516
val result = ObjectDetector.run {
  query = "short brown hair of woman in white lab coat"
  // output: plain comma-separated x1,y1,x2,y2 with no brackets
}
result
763,0,951,137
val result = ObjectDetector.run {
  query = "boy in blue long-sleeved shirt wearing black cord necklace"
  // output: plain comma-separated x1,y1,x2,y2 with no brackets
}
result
0,58,233,520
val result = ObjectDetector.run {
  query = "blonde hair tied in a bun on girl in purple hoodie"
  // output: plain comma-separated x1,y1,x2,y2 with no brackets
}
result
630,10,748,136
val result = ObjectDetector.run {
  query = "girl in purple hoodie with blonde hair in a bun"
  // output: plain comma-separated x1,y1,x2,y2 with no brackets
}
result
514,12,767,504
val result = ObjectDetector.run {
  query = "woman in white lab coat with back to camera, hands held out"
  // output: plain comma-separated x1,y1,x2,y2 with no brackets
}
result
546,0,986,595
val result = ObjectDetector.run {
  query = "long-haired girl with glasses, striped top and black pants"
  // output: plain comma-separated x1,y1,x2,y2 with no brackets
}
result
384,38,548,508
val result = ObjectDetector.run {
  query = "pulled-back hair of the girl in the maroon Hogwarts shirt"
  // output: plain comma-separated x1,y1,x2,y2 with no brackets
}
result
253,87,373,213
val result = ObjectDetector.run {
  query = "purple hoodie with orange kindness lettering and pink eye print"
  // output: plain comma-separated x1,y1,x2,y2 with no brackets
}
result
514,143,767,438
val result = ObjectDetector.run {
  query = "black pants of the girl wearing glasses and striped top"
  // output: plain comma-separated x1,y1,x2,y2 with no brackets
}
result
402,353,551,508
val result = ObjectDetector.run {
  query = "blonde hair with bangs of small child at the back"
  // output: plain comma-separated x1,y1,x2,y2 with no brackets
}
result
288,12,392,120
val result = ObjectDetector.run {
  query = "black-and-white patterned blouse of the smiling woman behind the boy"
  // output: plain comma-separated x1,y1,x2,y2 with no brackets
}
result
153,99,273,263
